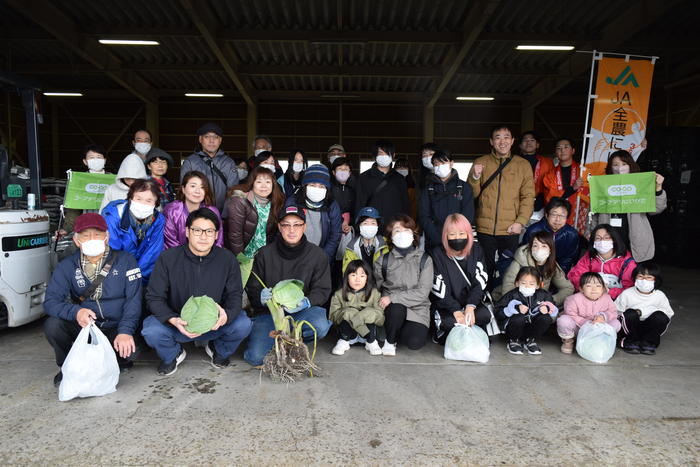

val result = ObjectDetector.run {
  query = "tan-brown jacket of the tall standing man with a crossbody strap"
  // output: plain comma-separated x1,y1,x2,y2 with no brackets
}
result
467,152,535,235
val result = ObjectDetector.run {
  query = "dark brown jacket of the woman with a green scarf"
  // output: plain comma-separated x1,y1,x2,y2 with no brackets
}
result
226,190,275,255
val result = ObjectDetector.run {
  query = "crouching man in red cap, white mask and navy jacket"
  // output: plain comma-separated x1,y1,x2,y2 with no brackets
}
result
44,212,141,386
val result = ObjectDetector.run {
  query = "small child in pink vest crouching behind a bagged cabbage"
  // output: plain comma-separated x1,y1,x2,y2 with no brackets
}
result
557,272,620,354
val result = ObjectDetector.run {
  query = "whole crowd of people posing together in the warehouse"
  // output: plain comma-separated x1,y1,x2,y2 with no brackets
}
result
45,123,673,390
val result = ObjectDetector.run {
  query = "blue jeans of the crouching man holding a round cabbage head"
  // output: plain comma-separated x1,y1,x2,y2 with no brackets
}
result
141,311,252,363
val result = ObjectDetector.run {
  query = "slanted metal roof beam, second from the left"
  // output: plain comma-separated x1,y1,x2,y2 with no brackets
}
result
180,0,255,106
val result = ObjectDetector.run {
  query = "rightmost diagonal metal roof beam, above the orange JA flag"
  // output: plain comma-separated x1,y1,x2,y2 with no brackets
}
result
523,0,680,108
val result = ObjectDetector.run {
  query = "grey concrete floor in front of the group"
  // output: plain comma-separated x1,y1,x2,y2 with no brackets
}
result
0,268,700,465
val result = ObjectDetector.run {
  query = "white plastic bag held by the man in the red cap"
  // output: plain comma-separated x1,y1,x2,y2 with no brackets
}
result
58,323,119,401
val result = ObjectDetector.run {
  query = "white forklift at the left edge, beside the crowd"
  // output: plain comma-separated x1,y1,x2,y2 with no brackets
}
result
0,72,51,329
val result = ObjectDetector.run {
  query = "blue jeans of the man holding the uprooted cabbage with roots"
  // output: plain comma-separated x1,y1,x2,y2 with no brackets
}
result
243,306,331,366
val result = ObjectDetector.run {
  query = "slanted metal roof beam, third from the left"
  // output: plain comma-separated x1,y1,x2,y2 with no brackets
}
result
426,0,500,107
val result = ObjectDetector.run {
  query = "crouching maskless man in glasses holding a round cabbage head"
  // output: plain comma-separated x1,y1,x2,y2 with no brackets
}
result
141,208,251,375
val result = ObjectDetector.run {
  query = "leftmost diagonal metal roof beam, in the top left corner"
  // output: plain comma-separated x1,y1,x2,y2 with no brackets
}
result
5,0,158,103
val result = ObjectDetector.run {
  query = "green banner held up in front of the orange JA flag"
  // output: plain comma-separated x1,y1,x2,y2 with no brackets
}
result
589,172,656,214
